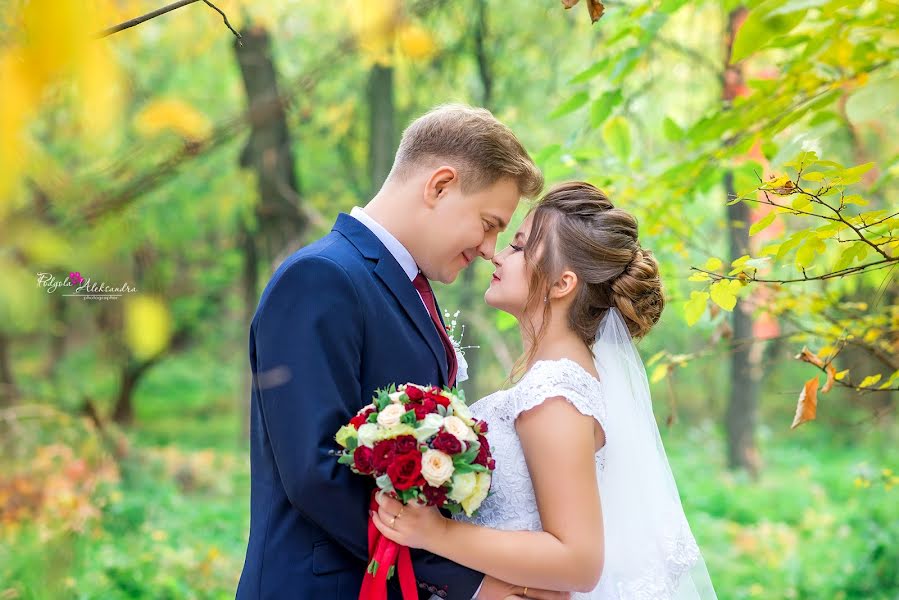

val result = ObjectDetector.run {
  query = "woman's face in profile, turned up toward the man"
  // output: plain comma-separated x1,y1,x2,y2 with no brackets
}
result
484,214,534,320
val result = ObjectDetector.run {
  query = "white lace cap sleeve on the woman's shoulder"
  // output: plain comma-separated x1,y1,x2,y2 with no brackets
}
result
507,360,606,431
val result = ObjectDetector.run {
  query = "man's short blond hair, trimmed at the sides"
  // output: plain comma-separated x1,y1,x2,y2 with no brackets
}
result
390,104,543,198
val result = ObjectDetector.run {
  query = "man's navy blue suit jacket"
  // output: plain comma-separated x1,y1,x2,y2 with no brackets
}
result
237,214,483,600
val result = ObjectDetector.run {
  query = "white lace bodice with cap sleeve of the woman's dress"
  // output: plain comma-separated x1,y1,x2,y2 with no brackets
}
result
456,359,614,531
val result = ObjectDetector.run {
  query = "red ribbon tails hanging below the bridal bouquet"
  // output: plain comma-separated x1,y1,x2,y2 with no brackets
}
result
359,490,418,600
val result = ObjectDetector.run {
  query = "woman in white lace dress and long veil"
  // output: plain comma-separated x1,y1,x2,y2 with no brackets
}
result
374,182,715,600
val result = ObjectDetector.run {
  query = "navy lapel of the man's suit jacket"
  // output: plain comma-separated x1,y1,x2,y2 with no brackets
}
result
334,213,449,385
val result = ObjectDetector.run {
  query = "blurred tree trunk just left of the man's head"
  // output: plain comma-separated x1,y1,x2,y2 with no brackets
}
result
368,65,397,196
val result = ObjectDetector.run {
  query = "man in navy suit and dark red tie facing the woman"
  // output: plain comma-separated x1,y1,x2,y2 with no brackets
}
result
237,105,543,600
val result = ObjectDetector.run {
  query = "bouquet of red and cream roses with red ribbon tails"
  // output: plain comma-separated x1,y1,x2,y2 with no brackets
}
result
335,383,495,600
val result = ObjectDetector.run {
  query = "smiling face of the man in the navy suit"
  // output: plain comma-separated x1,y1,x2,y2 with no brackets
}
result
416,178,520,283
